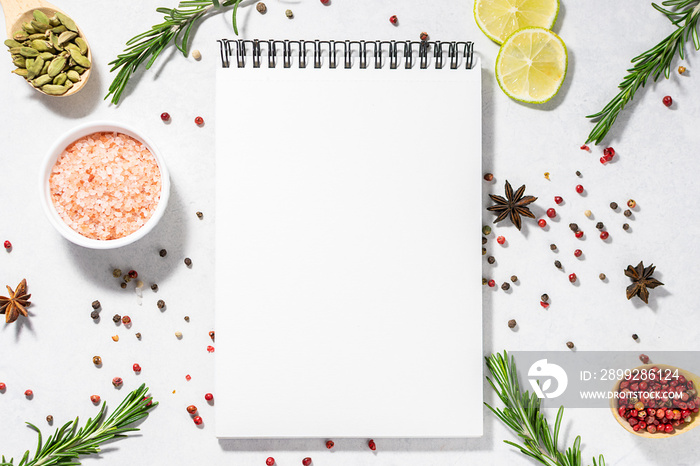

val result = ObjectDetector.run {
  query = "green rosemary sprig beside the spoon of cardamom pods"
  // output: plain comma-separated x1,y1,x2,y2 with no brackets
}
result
105,0,242,104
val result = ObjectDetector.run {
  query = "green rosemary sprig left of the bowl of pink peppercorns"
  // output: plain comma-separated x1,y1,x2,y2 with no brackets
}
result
484,351,605,466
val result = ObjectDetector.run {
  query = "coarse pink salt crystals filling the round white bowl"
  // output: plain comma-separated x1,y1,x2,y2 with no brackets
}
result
49,132,161,240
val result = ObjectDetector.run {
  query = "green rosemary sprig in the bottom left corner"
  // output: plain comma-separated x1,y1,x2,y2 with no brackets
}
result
0,384,158,466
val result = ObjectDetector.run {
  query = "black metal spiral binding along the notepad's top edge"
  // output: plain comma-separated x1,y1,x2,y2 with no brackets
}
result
218,39,474,70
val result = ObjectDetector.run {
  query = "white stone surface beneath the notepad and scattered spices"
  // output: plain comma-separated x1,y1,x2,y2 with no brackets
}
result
0,0,700,466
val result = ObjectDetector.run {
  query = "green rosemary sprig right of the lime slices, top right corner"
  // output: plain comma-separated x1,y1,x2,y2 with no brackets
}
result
586,0,700,144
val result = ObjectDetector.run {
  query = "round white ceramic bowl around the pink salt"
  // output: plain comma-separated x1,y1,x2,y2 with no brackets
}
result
40,121,170,249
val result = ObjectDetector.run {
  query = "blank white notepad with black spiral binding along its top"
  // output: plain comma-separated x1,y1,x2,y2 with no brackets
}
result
216,40,483,438
